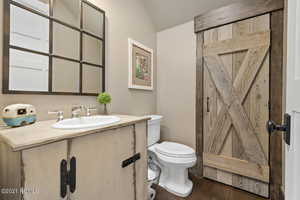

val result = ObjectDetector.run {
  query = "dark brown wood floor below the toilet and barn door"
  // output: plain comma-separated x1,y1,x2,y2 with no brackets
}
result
155,178,266,200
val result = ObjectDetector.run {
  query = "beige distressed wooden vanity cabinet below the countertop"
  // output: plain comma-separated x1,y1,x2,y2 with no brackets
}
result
0,122,147,200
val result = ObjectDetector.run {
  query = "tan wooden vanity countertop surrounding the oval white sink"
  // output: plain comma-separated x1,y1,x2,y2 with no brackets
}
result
0,115,150,151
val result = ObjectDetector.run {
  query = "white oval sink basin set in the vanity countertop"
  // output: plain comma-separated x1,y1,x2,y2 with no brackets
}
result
52,115,121,129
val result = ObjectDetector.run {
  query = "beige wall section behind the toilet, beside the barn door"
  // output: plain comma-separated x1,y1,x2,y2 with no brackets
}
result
157,21,196,148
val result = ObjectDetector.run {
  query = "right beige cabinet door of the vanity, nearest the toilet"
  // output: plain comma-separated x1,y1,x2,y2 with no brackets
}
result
70,126,135,200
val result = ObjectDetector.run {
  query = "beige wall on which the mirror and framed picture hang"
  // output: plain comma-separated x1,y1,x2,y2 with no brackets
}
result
0,0,156,123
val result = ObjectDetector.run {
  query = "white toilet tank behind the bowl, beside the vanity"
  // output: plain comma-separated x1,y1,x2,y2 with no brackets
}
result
147,115,162,146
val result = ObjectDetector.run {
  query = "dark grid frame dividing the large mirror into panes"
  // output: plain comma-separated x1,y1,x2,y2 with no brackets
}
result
2,0,106,96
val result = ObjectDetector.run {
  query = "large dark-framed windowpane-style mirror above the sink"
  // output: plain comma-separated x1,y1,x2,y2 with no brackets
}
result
3,0,105,96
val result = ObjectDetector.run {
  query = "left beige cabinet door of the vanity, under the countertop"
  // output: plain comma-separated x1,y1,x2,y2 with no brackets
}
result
22,141,67,200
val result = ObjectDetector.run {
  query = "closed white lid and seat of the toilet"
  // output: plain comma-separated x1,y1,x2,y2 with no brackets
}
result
155,142,195,158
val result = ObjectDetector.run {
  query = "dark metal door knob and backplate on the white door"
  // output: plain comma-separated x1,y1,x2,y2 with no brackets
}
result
267,114,291,145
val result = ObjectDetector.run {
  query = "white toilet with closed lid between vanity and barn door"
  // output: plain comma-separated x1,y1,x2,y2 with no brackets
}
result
148,115,197,197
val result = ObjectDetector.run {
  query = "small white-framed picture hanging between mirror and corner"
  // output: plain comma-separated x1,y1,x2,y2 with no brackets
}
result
128,39,153,90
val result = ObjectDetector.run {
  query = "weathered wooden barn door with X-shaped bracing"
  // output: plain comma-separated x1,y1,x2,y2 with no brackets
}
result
203,14,270,197
